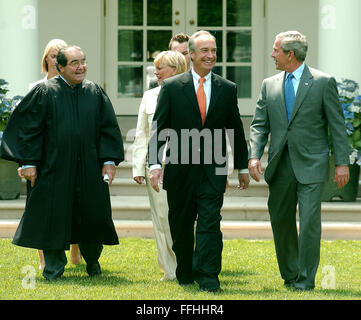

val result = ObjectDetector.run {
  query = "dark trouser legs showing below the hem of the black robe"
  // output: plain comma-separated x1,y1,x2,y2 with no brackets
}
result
43,242,103,280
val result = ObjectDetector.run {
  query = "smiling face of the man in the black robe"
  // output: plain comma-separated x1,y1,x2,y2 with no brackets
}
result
59,48,87,86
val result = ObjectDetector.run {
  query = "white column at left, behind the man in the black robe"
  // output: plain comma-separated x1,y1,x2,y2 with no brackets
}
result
0,0,40,97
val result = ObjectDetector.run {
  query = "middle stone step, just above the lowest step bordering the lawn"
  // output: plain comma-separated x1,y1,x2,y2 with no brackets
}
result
4,196,361,223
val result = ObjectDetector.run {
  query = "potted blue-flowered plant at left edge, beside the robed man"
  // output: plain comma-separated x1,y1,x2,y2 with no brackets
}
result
0,79,22,200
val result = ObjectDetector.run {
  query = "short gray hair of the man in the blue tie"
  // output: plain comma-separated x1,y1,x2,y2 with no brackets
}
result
276,31,308,61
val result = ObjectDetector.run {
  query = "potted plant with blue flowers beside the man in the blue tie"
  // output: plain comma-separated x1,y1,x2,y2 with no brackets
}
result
322,79,361,201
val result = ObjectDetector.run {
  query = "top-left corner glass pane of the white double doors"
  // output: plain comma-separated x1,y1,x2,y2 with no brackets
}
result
118,0,143,26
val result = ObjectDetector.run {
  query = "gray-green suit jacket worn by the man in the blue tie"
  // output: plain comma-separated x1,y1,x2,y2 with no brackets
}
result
249,65,349,184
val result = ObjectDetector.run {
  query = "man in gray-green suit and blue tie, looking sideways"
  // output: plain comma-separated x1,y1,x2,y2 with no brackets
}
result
248,31,349,290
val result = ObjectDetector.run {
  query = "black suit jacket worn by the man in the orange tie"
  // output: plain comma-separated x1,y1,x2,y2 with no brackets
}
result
149,70,247,193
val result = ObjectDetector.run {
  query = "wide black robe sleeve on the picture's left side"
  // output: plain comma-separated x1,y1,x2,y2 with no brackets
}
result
0,84,47,165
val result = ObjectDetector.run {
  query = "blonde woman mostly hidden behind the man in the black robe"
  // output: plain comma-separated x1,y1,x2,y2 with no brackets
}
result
23,39,82,270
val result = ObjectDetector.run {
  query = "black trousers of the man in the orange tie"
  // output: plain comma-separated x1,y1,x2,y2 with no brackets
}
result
167,174,223,289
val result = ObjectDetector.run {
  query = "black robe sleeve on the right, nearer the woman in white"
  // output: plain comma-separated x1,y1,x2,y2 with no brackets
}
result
98,86,124,165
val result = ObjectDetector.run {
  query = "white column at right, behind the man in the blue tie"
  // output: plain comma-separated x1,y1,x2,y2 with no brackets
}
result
318,0,361,85
